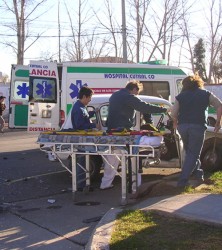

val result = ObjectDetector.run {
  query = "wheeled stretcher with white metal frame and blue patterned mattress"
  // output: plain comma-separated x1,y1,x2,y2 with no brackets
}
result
37,131,164,204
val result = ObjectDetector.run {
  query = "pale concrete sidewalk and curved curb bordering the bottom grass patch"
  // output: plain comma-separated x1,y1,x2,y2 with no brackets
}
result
85,189,222,250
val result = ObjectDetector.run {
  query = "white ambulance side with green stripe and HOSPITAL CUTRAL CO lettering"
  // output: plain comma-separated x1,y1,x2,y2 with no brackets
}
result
61,62,186,118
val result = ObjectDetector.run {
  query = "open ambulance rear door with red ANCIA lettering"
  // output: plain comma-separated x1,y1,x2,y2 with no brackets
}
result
28,61,60,132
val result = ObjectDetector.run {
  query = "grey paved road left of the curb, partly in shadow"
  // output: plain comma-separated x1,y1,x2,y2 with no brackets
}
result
0,131,130,250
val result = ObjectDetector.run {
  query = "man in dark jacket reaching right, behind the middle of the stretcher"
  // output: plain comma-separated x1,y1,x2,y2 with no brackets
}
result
100,81,167,189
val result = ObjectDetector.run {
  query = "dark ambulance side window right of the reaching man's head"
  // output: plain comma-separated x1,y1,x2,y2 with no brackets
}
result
140,81,170,100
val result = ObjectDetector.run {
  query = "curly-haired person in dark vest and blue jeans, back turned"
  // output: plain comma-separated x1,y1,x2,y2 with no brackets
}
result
171,75,222,187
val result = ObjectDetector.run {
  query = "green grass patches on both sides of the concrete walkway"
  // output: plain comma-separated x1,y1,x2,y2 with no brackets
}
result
110,171,222,250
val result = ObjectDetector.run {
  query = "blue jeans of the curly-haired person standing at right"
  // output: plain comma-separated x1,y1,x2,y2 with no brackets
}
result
178,124,206,187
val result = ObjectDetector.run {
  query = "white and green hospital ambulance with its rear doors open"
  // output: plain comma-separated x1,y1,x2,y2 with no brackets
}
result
9,61,186,132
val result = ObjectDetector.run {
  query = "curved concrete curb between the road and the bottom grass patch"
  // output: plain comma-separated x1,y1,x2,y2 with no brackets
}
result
85,208,123,250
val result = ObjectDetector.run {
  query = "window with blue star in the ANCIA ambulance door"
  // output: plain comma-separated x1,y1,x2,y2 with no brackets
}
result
29,78,57,103
